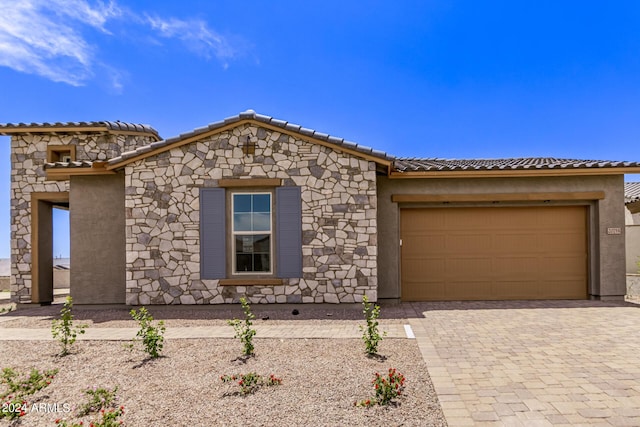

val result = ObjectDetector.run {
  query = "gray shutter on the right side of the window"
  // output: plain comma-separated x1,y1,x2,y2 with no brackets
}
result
276,187,302,278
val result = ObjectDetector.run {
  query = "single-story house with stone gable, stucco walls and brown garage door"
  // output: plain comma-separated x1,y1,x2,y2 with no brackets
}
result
0,110,640,305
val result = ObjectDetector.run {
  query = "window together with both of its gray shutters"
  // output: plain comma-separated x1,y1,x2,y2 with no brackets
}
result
200,186,302,280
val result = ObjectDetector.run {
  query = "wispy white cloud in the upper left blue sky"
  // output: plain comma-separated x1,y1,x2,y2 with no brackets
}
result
0,0,235,91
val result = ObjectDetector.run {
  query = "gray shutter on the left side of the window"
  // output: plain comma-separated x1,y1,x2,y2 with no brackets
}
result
200,188,227,279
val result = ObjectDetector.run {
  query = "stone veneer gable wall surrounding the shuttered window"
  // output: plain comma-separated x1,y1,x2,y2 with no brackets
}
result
125,125,377,305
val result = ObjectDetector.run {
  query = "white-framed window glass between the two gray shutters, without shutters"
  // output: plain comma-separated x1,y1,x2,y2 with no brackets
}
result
231,193,273,274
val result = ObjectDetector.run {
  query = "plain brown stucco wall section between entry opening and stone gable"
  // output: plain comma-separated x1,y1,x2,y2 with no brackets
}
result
69,174,126,304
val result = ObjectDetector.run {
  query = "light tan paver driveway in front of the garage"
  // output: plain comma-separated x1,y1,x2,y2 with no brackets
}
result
410,301,640,427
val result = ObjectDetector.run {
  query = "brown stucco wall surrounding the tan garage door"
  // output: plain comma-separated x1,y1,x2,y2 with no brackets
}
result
378,176,626,299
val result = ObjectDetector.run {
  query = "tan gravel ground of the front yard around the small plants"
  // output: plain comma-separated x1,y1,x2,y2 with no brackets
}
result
0,306,446,426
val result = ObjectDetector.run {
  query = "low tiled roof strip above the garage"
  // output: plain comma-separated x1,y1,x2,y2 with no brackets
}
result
394,157,640,172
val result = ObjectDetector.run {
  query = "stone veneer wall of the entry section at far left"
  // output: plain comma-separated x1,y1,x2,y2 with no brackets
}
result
10,134,153,302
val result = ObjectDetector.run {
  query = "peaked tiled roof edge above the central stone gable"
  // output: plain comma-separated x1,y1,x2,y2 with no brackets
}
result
109,110,394,165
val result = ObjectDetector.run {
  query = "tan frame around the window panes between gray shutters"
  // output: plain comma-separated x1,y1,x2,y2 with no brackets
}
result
227,188,277,277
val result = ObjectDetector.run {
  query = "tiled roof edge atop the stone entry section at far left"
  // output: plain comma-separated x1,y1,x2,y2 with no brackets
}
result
0,121,160,139
